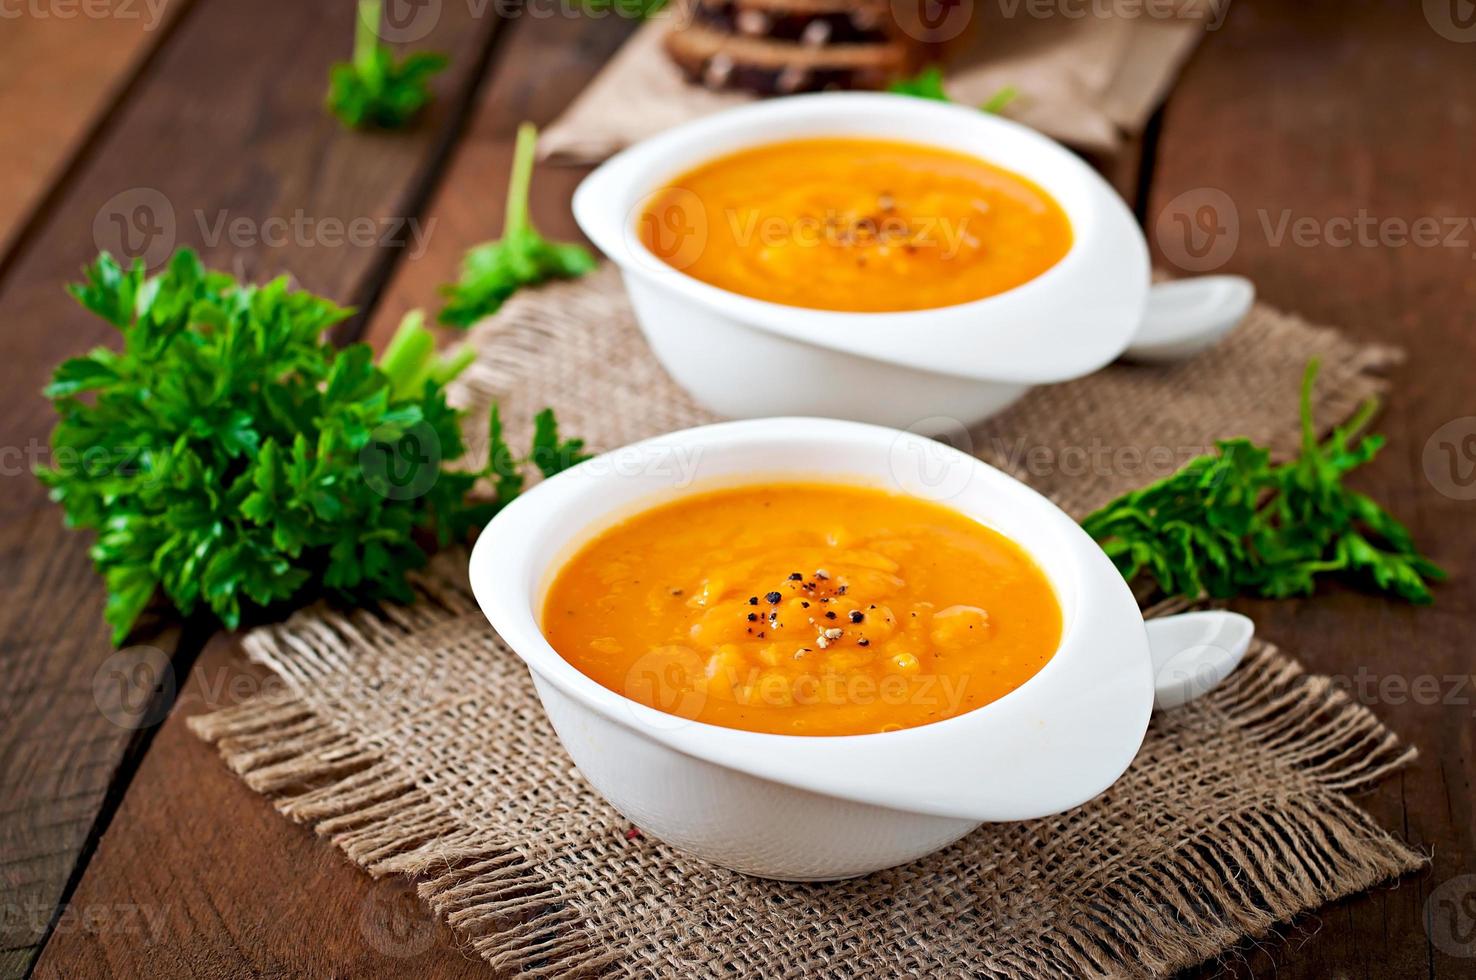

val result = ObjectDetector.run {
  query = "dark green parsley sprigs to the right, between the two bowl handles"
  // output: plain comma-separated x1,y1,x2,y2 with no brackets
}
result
1082,360,1445,602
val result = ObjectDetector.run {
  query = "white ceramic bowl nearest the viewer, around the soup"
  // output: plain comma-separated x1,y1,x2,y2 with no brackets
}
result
471,418,1249,880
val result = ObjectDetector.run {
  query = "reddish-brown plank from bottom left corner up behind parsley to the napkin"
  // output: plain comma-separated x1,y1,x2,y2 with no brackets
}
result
37,11,630,979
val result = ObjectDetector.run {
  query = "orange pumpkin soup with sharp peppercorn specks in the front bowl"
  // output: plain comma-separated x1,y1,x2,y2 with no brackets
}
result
543,483,1061,735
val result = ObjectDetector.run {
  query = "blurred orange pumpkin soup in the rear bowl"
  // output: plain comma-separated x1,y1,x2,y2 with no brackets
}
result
638,139,1072,313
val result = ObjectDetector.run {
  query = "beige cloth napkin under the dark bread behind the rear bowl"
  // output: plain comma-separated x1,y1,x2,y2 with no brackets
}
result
540,0,1228,162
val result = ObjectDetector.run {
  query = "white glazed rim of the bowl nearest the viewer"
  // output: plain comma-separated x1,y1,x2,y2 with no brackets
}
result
471,419,1153,821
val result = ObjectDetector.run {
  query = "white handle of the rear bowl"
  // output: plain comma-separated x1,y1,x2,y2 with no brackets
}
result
1123,276,1256,363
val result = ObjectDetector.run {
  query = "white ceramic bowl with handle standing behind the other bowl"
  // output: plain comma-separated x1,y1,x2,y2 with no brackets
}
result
574,93,1253,431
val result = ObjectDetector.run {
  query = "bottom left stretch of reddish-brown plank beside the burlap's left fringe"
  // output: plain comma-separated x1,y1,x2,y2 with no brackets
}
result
35,636,486,980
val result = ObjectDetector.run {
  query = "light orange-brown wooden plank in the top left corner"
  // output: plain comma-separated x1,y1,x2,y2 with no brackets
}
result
0,0,190,261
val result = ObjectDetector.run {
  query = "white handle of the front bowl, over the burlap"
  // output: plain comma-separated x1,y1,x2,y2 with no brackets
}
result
1147,610,1256,711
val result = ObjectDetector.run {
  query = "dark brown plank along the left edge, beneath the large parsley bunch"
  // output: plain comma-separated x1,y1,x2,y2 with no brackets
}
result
0,0,497,976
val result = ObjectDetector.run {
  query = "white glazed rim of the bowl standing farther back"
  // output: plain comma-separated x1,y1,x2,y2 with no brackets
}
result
573,93,1148,384
